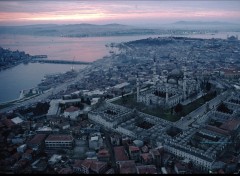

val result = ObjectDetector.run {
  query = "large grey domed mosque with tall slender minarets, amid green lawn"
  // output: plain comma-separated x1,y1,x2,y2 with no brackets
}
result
137,57,201,108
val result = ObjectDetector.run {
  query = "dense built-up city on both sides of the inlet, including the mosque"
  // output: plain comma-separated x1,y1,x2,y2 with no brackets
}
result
0,36,240,174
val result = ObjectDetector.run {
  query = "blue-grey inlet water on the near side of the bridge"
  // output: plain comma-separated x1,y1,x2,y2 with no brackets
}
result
0,63,86,104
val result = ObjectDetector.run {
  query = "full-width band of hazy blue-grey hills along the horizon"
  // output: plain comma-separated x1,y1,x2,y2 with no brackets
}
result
0,21,240,37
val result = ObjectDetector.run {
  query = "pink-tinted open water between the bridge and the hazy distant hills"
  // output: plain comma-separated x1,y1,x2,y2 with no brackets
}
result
0,32,239,62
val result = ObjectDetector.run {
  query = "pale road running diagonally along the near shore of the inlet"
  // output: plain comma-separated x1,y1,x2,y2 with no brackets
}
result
0,66,90,113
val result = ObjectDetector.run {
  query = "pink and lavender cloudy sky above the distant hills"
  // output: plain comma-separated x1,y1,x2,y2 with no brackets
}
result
0,0,240,26
